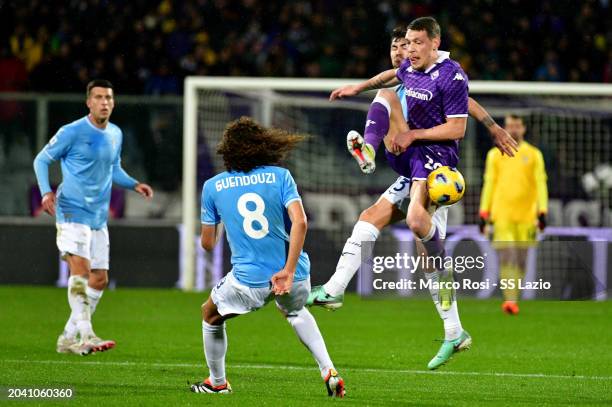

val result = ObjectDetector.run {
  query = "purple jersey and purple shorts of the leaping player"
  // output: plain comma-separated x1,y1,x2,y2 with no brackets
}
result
385,51,468,179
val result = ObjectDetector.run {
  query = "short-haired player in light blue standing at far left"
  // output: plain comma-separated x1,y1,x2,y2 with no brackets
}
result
34,79,153,355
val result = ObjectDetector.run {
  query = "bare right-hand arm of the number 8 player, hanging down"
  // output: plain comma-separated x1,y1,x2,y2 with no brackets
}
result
271,200,308,295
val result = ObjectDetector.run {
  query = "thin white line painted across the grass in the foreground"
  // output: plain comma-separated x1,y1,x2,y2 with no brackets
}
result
0,359,612,380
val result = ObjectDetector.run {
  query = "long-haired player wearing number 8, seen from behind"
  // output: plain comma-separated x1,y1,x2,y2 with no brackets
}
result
191,117,345,397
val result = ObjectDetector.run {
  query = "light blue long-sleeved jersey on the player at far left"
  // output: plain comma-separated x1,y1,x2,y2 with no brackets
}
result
34,116,137,229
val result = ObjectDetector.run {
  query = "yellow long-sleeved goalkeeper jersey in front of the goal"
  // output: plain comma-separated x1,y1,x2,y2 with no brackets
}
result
480,141,548,223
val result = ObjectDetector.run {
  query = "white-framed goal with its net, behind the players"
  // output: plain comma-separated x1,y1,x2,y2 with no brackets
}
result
182,77,612,298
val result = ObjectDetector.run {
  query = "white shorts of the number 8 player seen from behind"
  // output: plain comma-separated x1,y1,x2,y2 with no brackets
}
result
210,271,310,316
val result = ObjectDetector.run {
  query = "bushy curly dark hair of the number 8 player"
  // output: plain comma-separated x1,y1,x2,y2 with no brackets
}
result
217,116,305,172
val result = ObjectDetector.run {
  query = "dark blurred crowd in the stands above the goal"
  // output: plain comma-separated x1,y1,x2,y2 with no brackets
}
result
0,0,612,95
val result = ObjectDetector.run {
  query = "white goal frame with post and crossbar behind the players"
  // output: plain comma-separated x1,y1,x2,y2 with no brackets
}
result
180,76,612,290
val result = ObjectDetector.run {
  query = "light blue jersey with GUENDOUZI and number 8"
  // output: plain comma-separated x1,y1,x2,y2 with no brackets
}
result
201,166,310,287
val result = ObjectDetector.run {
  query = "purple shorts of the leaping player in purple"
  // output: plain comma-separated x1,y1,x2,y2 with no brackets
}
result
385,143,459,181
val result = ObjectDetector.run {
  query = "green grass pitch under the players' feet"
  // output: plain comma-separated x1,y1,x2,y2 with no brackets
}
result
0,286,612,406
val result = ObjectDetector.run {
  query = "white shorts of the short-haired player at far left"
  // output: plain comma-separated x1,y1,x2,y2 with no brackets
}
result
55,223,110,270
